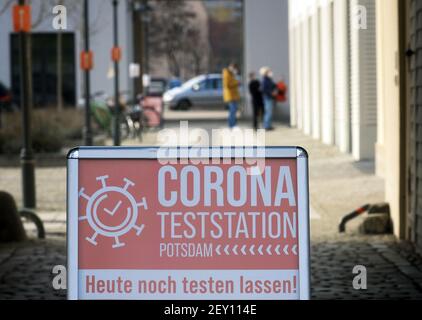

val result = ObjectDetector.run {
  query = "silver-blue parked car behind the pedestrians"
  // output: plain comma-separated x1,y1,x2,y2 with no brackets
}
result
163,74,246,110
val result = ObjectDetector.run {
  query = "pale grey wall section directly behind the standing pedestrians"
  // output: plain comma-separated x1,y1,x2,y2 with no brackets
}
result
244,0,290,121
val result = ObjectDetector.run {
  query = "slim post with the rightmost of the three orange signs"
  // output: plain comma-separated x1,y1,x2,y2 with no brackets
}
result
112,0,120,146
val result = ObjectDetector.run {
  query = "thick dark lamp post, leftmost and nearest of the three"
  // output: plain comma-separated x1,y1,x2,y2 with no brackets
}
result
18,0,36,208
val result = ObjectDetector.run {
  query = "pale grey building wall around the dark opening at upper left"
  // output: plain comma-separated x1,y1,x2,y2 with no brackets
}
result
0,0,133,106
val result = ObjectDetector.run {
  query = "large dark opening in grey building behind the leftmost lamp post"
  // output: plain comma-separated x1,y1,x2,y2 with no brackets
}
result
10,32,76,107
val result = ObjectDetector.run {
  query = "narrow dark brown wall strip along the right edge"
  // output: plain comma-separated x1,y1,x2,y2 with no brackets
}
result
400,0,422,250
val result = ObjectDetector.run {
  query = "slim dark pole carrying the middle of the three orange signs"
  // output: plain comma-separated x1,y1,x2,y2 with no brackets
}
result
84,0,93,146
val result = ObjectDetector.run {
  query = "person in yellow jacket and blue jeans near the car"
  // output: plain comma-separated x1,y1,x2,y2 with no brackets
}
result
223,63,240,128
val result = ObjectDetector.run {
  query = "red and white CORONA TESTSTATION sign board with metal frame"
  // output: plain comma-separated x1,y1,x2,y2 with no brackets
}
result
67,147,309,300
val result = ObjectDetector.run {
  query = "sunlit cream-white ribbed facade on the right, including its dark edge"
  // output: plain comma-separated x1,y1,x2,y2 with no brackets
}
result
289,0,422,249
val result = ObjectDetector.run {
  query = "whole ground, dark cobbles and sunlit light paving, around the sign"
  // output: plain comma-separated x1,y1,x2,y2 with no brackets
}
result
0,121,422,299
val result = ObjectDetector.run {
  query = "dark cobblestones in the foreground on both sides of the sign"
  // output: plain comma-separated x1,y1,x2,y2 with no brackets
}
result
0,236,422,299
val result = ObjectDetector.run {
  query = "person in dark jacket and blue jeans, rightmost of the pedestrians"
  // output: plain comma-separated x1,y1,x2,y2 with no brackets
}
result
260,67,278,131
